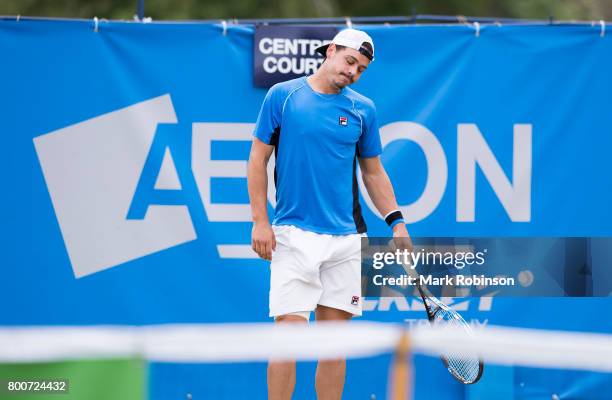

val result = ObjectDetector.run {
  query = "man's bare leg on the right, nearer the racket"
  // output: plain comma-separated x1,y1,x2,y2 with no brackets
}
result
315,305,353,400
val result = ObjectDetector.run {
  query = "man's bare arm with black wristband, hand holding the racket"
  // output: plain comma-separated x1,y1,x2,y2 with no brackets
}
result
359,156,412,242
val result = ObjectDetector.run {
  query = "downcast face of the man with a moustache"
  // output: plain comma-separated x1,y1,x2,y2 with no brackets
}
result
325,44,370,89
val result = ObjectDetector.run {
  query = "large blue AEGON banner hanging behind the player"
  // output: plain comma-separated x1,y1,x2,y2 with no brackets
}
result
0,20,612,398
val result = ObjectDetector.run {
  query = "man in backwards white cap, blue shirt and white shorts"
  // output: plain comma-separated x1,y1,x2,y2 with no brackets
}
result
248,29,410,400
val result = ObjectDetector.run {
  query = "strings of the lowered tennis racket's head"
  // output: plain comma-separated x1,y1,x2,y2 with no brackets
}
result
434,308,481,383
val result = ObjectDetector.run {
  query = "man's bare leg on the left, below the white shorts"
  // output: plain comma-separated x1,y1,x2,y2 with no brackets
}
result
268,315,308,400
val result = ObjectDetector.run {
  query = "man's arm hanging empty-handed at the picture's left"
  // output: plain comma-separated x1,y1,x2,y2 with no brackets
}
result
247,137,276,260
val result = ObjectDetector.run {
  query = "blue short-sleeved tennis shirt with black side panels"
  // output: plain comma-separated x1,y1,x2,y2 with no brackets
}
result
254,77,382,235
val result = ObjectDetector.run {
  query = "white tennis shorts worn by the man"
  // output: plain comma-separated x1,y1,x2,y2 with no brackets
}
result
270,225,365,317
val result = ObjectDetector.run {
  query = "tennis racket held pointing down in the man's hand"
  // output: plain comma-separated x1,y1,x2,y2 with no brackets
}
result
408,268,484,385
